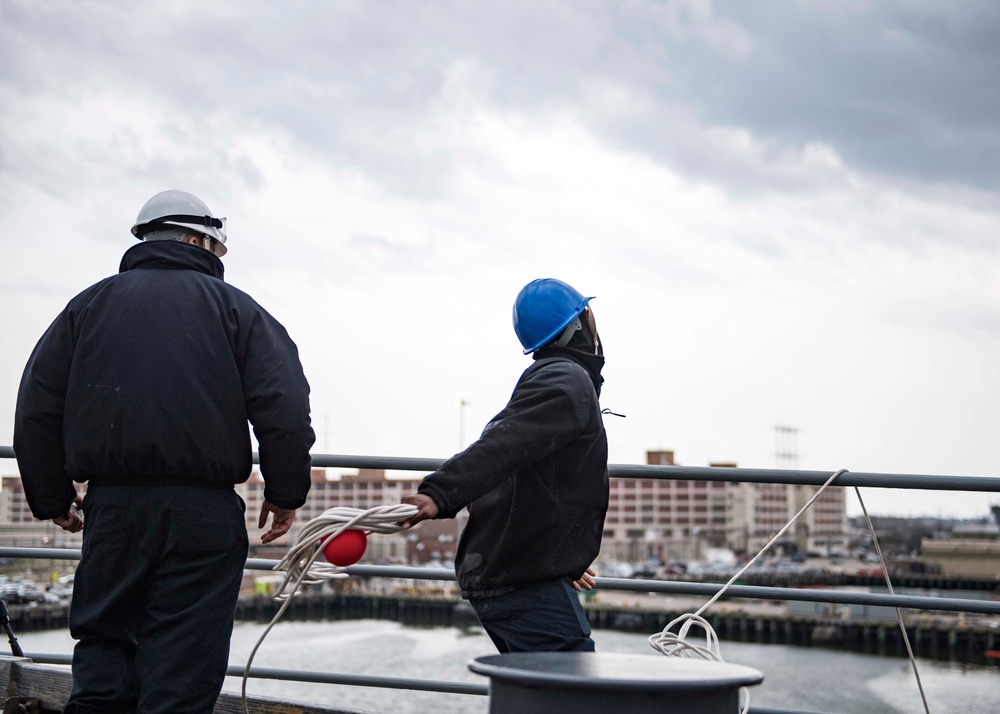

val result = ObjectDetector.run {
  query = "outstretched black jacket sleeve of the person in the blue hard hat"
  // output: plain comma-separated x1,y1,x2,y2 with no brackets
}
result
418,363,593,518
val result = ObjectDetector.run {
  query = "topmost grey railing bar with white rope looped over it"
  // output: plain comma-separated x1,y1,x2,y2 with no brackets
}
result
0,446,1000,493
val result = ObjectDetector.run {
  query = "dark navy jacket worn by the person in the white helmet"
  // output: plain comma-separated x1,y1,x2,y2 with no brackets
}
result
14,241,315,519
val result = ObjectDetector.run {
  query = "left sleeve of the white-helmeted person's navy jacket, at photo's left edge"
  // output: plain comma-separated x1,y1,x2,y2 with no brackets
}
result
14,308,82,520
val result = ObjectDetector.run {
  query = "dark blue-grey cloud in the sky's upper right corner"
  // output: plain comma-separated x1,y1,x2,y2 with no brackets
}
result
656,2,1000,190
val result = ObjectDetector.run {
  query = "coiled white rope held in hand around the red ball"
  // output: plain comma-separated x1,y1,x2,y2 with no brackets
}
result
242,503,417,714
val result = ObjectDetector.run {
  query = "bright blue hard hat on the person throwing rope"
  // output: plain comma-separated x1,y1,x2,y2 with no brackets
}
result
514,278,594,354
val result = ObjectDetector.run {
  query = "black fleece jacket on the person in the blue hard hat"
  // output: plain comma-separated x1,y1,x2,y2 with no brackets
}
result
419,348,608,599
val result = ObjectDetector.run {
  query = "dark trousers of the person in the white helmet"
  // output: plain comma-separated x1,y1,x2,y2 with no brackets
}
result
63,486,248,714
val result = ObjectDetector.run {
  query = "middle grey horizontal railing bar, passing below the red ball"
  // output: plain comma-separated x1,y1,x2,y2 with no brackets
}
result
7,548,1000,615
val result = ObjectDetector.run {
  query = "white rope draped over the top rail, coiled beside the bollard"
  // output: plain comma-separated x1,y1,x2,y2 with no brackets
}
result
648,469,930,714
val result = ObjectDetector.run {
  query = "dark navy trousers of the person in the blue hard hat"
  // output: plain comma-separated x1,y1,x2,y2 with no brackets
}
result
469,578,594,653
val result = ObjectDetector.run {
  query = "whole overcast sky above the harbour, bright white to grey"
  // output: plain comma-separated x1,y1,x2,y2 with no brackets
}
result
0,0,1000,516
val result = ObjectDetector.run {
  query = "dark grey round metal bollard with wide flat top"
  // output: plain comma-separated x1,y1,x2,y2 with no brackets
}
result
469,652,764,714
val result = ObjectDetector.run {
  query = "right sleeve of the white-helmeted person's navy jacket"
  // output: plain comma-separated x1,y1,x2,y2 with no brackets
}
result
241,307,316,509
